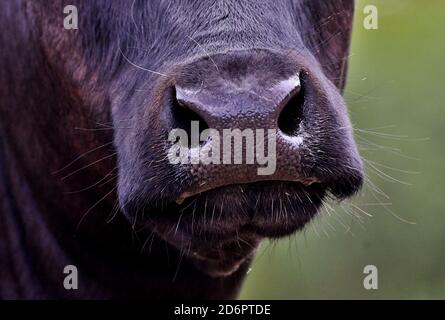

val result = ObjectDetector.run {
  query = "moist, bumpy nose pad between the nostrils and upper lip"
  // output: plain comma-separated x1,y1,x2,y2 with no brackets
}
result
166,72,313,202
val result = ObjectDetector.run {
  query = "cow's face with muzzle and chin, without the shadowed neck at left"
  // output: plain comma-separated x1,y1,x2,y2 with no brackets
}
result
40,0,362,276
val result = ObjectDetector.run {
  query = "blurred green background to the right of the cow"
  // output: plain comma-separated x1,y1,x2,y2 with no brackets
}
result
240,0,445,299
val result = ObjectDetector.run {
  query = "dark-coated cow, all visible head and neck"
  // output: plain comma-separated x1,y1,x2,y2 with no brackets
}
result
0,0,363,299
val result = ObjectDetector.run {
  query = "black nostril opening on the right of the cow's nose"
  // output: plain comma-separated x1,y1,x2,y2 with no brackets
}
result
278,81,304,136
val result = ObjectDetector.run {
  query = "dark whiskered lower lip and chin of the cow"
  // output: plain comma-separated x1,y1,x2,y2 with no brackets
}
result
130,181,327,277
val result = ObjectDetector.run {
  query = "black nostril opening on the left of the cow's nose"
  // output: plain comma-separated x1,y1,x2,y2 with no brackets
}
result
171,88,209,141
